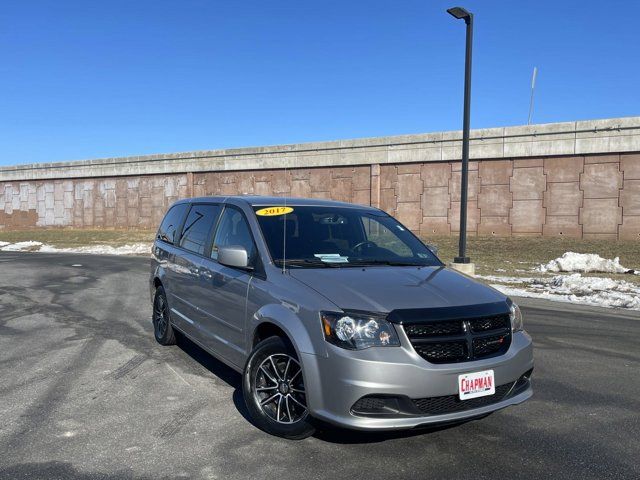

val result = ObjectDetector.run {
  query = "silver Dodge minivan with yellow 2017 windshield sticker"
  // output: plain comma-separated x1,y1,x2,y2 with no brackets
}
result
150,196,533,439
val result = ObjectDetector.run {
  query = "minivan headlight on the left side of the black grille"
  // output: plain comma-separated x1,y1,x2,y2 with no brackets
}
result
320,312,400,350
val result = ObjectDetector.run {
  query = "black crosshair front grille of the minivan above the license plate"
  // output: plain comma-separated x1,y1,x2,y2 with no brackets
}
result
404,314,511,363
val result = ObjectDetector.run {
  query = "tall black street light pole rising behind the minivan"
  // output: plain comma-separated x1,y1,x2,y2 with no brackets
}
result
447,7,473,263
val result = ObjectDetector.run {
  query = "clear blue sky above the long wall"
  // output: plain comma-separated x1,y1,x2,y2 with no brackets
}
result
0,0,640,165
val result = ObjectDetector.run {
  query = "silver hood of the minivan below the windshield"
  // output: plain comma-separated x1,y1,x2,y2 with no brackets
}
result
289,266,507,313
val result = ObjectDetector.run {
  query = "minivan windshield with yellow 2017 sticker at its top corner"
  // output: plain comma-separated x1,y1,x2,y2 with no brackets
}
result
254,205,442,268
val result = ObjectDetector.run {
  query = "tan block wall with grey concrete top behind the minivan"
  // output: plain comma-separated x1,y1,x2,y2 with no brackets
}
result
0,117,640,239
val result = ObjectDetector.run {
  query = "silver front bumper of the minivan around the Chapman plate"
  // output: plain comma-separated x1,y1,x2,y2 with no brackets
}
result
301,332,533,430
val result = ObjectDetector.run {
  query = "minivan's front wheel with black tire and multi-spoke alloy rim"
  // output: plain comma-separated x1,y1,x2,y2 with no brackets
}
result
242,337,315,440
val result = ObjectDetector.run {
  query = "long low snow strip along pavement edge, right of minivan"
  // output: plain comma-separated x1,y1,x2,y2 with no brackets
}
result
491,273,640,310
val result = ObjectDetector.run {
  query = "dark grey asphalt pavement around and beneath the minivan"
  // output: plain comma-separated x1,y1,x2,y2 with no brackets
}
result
0,252,640,480
